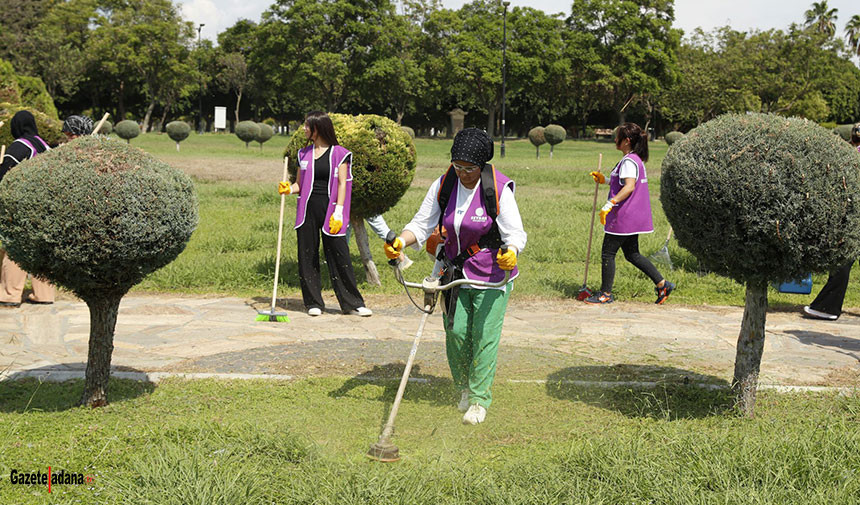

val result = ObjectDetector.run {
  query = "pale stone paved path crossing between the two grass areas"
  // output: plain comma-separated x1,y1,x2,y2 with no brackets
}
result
0,296,860,385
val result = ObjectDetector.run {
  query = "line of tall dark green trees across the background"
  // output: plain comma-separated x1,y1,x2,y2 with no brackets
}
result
0,0,860,136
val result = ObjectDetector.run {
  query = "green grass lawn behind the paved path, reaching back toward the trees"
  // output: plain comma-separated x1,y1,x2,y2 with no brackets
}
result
117,134,860,307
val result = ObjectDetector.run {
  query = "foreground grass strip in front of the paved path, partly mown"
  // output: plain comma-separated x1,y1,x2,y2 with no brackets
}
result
0,378,860,504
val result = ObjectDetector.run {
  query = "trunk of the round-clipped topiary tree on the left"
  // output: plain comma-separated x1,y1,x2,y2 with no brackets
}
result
81,296,122,407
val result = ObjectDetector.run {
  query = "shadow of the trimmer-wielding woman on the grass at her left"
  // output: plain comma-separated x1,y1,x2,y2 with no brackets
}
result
328,363,458,429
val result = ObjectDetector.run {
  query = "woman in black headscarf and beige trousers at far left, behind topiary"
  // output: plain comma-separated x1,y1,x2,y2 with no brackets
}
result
0,110,54,307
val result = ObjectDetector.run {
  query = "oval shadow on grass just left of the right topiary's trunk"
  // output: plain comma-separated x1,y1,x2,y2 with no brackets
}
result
546,364,734,420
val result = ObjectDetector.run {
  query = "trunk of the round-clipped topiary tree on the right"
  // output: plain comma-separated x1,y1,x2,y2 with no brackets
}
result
732,283,767,417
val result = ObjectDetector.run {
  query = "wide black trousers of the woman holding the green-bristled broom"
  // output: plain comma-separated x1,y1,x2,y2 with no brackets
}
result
296,195,364,314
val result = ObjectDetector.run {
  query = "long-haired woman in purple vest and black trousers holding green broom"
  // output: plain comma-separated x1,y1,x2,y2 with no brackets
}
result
278,112,373,316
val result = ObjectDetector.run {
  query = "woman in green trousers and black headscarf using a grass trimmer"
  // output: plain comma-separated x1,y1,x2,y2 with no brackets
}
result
385,128,526,424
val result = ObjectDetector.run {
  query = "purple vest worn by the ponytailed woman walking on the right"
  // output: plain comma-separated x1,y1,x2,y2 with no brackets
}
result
604,153,654,235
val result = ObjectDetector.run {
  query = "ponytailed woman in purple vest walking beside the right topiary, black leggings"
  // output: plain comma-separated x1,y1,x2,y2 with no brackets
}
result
585,123,675,304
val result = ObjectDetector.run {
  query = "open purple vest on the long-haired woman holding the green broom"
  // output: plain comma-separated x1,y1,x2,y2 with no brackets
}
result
295,145,352,236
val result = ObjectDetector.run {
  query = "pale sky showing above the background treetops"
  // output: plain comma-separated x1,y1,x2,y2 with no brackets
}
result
177,0,860,41
